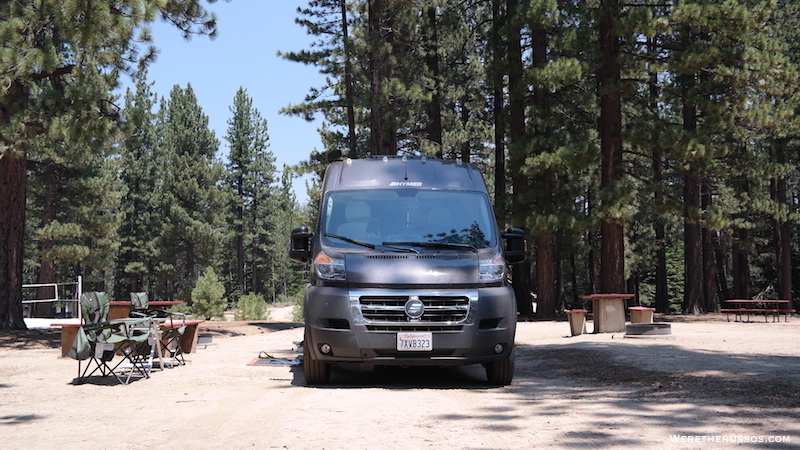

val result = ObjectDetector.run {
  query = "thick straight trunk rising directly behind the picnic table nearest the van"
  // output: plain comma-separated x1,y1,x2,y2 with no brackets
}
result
597,0,625,293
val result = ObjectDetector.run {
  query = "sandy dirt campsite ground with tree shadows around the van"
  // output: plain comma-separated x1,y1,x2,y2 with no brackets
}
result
0,314,800,449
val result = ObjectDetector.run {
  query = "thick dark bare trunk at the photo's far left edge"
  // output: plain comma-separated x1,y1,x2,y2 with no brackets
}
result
0,152,27,330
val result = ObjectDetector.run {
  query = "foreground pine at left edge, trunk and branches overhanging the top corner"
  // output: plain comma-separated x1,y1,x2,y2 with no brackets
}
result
0,0,215,329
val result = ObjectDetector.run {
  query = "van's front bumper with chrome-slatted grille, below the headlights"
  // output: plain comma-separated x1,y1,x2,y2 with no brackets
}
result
305,286,516,366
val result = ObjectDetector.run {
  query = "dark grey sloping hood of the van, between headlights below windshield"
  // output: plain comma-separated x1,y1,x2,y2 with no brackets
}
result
344,252,480,287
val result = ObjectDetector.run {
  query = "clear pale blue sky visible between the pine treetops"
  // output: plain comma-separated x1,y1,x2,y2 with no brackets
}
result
130,0,324,202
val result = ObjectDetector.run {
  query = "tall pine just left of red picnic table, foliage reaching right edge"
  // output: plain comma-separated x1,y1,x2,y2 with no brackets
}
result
667,1,793,312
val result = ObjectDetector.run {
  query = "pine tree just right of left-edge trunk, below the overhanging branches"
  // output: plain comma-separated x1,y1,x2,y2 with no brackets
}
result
27,135,122,308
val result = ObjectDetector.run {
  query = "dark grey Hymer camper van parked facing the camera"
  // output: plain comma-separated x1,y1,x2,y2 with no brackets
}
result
289,156,525,385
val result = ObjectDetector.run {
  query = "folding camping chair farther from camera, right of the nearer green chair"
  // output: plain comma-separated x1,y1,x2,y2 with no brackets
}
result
130,292,186,369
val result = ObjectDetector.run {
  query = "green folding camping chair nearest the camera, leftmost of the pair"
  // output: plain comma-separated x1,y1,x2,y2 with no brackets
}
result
67,292,150,384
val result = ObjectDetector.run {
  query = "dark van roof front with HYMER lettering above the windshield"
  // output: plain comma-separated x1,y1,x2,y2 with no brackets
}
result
322,156,486,192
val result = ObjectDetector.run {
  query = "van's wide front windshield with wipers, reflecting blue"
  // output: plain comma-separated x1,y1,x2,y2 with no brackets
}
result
321,188,496,249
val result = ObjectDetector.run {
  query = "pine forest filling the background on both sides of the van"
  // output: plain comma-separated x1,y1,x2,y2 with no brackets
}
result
0,0,800,328
